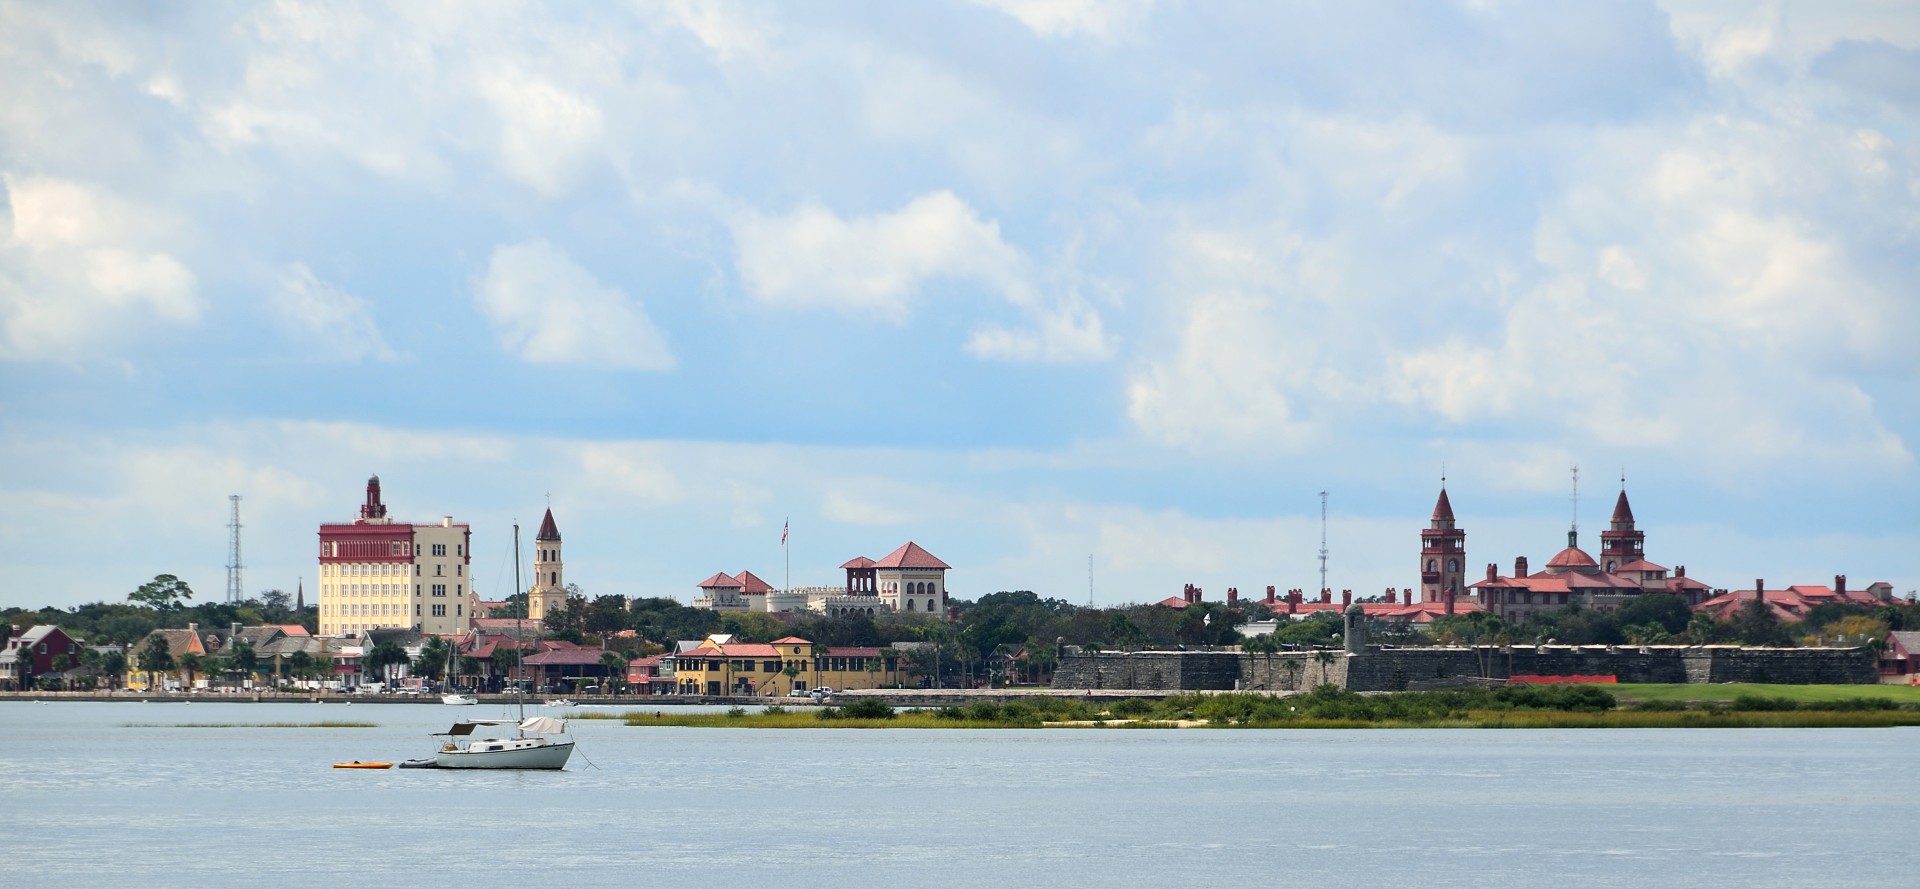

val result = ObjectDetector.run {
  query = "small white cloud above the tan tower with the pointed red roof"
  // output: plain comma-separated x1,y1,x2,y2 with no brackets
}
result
474,240,674,371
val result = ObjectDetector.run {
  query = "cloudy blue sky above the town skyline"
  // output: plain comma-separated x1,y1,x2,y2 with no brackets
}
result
0,0,1920,607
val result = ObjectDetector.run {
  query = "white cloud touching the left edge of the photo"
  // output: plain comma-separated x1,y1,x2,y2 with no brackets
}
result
0,177,204,361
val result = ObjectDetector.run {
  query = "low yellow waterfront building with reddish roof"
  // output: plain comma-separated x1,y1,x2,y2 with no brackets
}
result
674,636,904,697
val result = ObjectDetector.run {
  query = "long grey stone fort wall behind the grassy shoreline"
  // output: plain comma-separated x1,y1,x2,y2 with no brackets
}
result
1054,645,1880,691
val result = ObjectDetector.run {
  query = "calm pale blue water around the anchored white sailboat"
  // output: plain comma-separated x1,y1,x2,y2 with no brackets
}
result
0,703,1920,889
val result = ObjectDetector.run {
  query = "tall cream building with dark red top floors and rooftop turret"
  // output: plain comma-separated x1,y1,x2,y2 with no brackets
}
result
319,476,480,636
